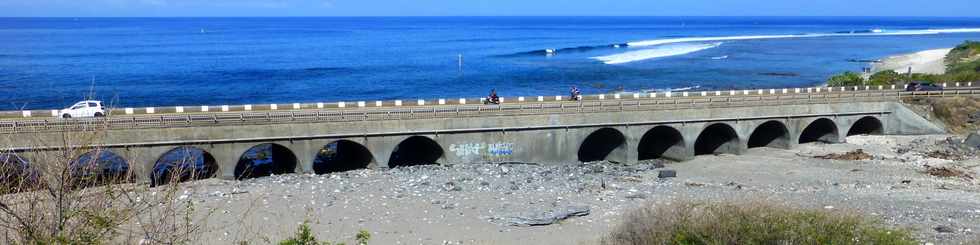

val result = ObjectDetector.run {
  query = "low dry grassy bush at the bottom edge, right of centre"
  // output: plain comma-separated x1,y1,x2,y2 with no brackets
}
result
601,202,918,245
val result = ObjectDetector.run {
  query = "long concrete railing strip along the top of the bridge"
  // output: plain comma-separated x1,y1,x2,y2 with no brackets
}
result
0,87,980,133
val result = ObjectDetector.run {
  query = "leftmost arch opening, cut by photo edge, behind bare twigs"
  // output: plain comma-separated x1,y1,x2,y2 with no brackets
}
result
0,153,40,195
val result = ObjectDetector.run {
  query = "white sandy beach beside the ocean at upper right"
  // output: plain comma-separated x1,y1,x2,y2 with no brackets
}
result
871,48,952,74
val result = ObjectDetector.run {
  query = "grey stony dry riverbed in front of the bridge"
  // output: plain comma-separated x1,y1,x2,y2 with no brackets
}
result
174,135,980,244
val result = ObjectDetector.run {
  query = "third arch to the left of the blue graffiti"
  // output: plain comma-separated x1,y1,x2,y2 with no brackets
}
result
235,143,298,180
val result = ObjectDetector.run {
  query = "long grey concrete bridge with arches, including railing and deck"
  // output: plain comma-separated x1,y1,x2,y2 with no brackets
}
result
0,87,964,184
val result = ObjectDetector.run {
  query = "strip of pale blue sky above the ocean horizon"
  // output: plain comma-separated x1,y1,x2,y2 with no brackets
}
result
0,0,980,17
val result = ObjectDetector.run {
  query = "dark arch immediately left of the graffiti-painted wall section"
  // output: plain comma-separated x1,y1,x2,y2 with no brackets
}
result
388,136,445,168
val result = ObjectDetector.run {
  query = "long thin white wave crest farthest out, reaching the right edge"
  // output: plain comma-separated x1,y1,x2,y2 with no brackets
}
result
627,28,980,47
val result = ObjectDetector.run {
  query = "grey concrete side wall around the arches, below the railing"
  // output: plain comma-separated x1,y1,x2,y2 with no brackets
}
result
0,102,942,183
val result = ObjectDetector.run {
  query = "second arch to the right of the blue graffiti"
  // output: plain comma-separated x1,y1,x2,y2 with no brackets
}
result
637,126,687,161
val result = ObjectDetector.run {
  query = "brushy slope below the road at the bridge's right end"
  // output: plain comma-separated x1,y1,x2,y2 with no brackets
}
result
904,97,980,134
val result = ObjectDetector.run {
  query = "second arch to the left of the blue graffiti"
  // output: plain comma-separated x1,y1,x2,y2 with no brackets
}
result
313,140,374,174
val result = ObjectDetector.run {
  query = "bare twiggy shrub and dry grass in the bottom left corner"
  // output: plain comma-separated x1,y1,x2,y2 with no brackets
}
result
0,130,210,244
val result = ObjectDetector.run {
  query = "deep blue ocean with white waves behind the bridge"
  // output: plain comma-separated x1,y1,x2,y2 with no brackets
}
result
0,17,980,110
